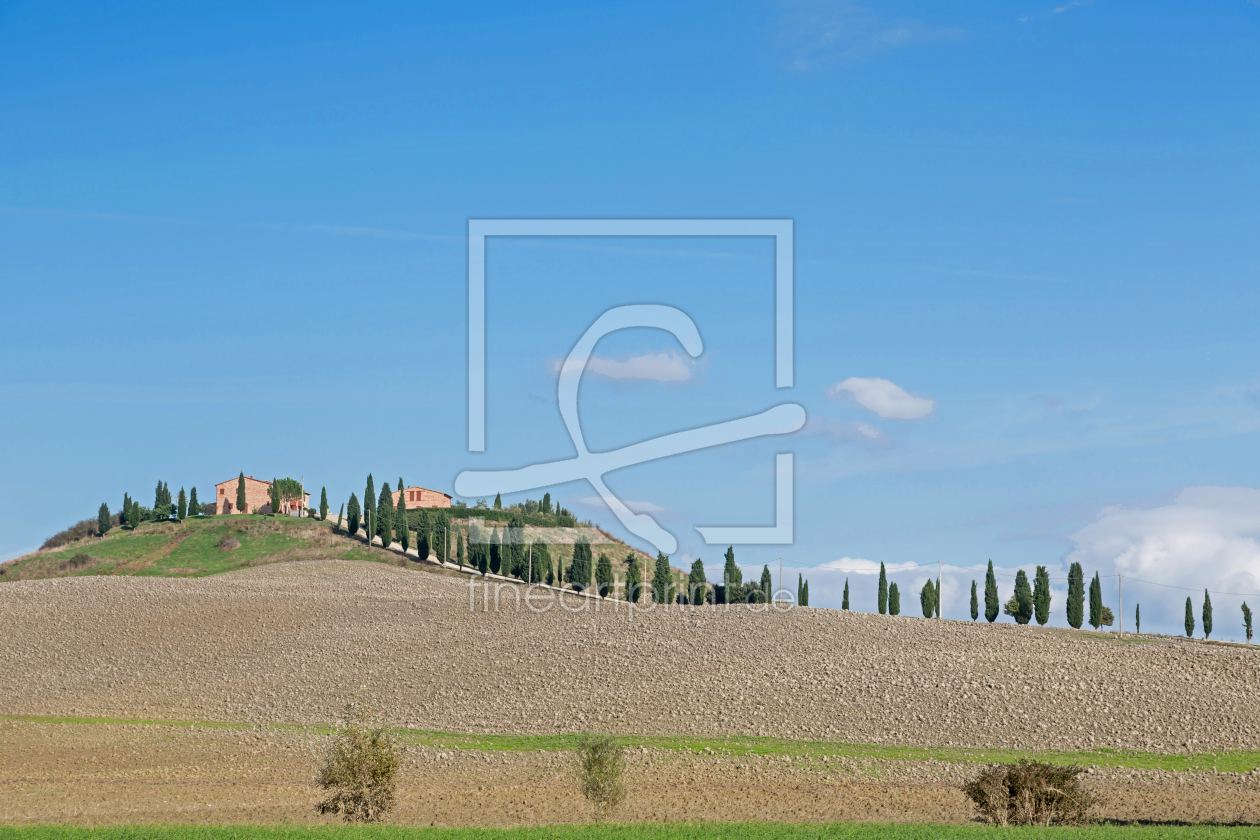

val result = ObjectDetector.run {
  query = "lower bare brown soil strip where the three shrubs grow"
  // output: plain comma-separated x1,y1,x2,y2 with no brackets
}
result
0,722,1260,826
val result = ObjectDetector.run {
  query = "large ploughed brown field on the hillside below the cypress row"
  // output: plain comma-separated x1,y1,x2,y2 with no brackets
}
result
0,560,1260,752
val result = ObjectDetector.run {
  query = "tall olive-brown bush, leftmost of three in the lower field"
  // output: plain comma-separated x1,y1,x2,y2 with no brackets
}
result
315,691,403,822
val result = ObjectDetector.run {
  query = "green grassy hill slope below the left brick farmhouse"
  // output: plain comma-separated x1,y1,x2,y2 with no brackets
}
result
0,515,385,582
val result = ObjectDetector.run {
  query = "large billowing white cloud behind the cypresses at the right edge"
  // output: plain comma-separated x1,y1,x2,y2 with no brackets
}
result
1066,487,1260,604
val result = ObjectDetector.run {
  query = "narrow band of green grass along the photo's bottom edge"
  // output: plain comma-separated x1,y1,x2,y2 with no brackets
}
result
0,822,1260,840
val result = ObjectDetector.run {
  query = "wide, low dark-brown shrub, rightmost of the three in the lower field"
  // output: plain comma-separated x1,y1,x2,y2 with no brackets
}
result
963,761,1092,825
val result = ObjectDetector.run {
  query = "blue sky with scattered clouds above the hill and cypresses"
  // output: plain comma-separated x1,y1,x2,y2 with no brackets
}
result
7,0,1260,637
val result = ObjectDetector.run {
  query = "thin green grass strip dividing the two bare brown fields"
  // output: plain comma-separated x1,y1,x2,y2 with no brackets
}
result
9,714,1260,772
